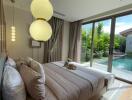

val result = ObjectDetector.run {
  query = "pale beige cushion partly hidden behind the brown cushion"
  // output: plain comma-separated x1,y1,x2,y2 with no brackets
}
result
30,58,45,84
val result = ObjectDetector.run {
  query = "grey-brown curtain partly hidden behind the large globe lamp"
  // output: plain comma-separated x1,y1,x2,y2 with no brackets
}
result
44,17,64,63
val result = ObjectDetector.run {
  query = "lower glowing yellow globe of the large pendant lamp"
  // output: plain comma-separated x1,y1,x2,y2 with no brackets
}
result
29,20,52,41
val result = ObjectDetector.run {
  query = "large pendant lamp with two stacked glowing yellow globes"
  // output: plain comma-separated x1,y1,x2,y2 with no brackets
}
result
29,0,53,41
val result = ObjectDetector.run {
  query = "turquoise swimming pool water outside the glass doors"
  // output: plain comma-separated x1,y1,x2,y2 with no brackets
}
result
101,56,132,71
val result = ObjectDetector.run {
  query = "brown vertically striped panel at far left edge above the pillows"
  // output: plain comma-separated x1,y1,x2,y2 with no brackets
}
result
0,0,6,54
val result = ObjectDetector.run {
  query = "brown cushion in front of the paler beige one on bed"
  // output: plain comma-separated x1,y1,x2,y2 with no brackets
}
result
19,65,45,100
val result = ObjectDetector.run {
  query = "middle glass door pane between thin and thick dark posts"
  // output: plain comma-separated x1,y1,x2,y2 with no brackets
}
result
92,19,111,71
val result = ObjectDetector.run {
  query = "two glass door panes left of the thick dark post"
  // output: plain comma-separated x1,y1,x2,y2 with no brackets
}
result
81,19,111,71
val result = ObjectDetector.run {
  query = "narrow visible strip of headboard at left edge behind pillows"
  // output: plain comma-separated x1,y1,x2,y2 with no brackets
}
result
0,53,6,100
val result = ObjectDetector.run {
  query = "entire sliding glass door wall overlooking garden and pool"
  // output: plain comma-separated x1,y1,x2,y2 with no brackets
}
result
81,12,132,82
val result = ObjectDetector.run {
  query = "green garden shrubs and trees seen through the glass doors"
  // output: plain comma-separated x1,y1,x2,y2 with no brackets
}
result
81,23,126,62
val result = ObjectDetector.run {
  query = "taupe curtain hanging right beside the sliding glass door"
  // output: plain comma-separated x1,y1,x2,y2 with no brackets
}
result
68,20,81,62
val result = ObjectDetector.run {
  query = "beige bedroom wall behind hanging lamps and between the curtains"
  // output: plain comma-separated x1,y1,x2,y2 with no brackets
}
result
4,5,69,62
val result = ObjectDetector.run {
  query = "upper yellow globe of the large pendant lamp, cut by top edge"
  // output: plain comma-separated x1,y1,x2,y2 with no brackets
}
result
31,0,53,21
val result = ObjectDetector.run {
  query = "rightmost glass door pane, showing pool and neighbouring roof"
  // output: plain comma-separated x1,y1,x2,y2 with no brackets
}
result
112,14,132,81
